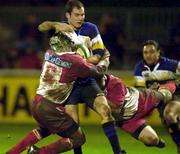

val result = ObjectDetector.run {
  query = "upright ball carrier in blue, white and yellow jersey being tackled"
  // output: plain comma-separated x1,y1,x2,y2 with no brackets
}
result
39,0,123,153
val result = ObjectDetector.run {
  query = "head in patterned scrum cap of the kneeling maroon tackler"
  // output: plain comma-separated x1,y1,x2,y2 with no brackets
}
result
49,32,78,53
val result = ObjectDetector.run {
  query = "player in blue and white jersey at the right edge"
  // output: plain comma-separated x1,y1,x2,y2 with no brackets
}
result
134,40,180,154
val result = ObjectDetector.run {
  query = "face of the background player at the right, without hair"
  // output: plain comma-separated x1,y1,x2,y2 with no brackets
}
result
143,45,160,65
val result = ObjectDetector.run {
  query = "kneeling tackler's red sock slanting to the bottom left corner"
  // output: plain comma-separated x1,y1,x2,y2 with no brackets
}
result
7,129,41,154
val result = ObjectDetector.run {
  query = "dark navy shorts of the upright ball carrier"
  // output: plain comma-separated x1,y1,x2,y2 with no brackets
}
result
66,78,104,108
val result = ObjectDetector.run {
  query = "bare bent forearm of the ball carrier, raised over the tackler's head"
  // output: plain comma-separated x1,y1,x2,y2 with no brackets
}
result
38,21,73,32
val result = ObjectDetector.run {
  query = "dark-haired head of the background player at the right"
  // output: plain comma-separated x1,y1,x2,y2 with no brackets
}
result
143,40,160,65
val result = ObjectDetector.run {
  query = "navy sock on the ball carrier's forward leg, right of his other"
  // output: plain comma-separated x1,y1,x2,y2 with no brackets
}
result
102,121,121,154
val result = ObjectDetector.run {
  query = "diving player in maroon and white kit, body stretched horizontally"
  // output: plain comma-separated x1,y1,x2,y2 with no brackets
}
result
104,75,176,148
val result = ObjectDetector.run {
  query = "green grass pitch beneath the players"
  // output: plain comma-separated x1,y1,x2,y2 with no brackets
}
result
0,124,176,154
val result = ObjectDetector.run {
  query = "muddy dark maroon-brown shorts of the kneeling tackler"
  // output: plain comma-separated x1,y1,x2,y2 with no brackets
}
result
32,98,79,137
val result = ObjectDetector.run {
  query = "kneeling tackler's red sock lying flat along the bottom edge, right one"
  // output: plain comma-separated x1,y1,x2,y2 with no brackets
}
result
37,138,73,154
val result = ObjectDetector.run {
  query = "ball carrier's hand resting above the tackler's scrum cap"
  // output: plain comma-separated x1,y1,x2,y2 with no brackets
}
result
54,23,74,33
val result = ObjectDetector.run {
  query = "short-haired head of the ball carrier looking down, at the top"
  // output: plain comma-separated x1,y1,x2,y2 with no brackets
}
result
65,0,85,29
